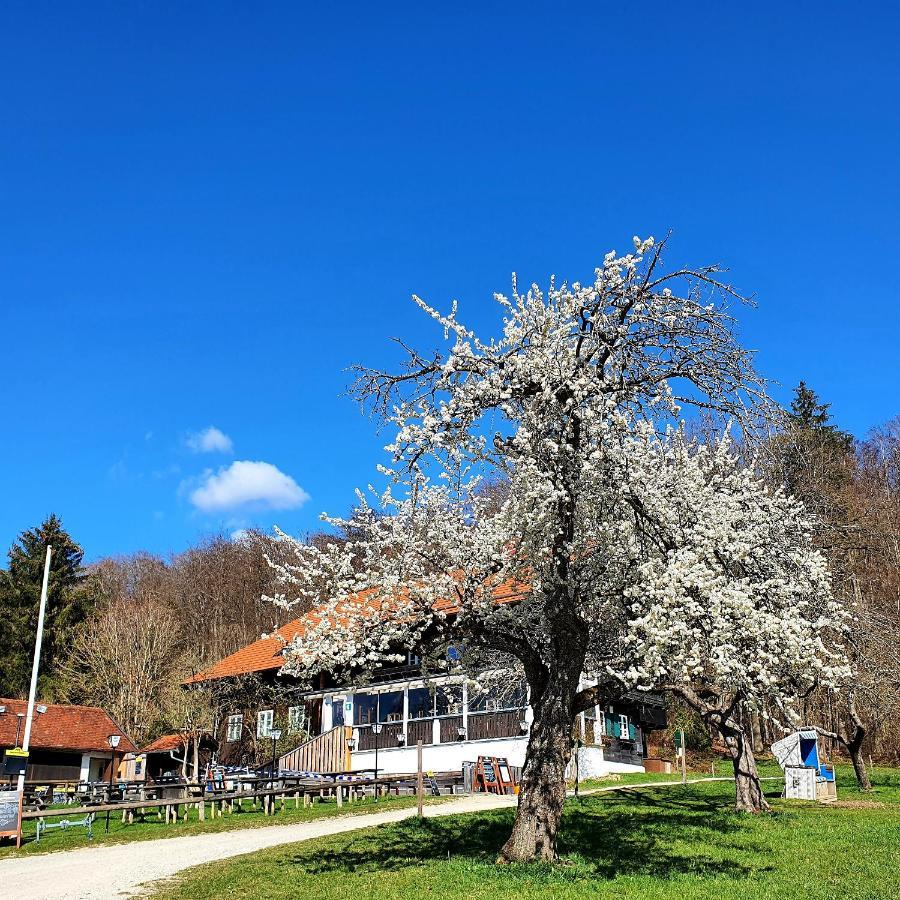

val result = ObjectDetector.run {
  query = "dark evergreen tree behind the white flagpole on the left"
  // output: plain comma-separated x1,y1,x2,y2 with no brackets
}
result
0,515,96,699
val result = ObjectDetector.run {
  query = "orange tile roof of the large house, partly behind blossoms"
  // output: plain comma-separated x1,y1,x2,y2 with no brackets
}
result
185,581,527,684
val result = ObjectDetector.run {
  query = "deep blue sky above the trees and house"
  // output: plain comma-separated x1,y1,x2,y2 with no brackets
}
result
0,2,900,559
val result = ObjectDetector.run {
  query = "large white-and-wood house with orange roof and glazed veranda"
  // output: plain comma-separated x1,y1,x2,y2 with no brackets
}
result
189,612,665,777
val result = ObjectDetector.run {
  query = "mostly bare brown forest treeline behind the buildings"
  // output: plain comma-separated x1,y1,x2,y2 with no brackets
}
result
0,382,900,763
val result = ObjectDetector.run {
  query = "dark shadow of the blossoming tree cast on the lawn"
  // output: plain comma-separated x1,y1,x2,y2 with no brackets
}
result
283,791,771,880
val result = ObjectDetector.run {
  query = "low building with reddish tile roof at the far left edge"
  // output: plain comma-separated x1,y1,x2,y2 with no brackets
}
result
0,699,137,782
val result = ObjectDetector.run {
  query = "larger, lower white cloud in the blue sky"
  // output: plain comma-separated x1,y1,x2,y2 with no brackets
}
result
190,460,309,512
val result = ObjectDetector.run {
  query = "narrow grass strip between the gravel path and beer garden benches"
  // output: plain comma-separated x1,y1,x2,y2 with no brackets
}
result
0,797,430,858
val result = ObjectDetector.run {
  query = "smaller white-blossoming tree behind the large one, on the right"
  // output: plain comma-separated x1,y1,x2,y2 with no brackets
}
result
622,435,850,812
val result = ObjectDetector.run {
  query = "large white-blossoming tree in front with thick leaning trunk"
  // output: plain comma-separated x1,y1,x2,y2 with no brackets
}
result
273,238,848,860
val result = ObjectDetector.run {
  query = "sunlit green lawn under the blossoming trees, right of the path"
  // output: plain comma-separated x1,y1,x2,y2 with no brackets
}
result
152,769,900,900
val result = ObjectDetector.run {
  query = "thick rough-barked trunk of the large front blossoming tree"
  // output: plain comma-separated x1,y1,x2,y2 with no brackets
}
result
497,652,582,862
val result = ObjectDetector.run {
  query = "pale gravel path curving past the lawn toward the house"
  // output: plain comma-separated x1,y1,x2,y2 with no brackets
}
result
0,778,731,900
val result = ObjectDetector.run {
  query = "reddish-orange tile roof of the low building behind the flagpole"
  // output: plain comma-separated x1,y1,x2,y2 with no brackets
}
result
0,698,137,753
